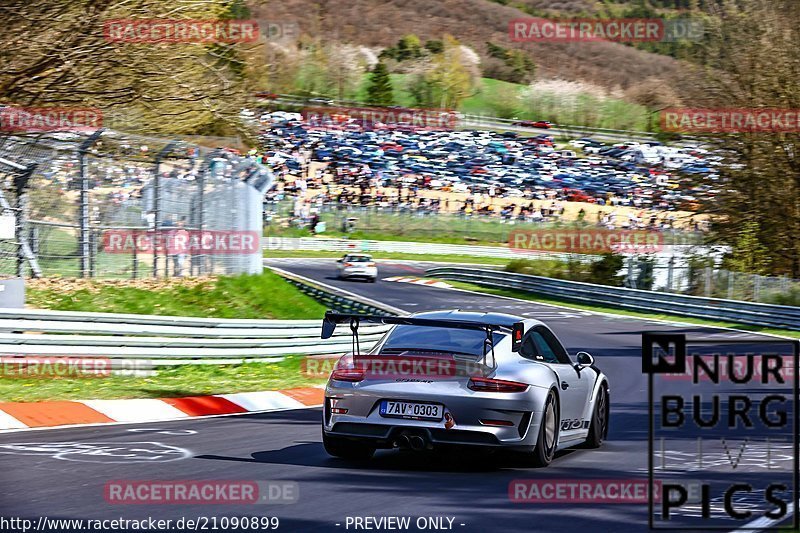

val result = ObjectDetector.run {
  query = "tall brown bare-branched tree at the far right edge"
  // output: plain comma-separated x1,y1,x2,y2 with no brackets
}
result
689,0,800,278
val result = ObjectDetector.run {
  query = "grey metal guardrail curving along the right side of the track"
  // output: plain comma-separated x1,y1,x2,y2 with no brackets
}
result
426,267,800,330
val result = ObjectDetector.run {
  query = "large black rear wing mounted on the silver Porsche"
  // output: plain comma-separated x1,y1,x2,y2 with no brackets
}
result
321,311,525,352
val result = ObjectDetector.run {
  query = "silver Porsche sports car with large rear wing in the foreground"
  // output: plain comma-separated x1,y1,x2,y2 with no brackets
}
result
322,310,609,466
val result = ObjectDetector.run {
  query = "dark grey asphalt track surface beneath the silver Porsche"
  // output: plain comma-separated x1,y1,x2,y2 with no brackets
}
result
0,259,792,532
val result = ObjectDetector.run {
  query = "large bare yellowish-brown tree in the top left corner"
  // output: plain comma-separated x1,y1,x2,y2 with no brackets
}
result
0,0,254,134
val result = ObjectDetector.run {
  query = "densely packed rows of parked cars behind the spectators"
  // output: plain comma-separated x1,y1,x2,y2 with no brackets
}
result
261,120,715,209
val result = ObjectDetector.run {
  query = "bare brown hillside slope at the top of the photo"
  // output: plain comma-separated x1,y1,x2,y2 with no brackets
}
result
252,0,682,89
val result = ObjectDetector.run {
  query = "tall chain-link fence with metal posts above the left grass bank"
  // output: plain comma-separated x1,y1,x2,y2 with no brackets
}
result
0,130,273,278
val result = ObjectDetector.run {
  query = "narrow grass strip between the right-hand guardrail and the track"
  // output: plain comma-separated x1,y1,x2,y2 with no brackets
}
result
447,280,800,339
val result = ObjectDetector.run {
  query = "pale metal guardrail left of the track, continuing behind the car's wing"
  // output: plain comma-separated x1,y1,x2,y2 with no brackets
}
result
0,269,403,364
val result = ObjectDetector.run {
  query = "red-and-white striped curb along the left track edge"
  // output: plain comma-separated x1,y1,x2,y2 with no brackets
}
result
0,387,324,431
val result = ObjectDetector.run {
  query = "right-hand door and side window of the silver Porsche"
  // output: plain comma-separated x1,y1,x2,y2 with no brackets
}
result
530,326,593,442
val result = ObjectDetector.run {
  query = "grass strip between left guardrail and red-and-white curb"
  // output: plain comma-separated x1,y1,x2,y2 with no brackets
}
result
0,356,325,402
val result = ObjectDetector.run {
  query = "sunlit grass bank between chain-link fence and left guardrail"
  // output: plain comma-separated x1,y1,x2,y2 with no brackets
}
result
26,271,325,319
